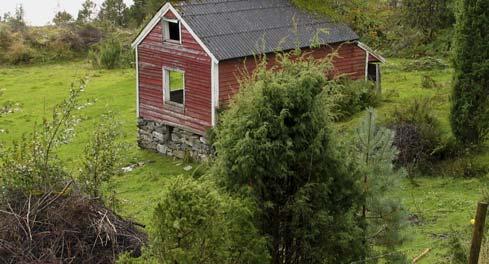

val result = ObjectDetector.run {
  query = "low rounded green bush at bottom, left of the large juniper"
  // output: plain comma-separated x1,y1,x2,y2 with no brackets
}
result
136,176,269,264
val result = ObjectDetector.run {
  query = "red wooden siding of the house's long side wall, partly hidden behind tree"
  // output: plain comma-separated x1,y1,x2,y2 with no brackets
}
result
219,43,366,107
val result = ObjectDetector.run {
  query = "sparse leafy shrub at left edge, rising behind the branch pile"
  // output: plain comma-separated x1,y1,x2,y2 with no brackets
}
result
0,81,85,193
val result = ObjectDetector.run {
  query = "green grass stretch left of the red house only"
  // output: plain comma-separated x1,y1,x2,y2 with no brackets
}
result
0,62,194,223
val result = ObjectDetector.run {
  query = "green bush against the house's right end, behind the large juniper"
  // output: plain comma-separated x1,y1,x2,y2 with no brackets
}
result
326,78,380,120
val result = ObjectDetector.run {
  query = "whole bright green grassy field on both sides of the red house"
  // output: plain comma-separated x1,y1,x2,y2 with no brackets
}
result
0,60,489,263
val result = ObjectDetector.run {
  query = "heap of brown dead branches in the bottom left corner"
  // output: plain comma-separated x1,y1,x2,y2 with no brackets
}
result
0,187,147,263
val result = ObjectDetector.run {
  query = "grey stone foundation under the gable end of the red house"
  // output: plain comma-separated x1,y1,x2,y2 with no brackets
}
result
138,118,212,161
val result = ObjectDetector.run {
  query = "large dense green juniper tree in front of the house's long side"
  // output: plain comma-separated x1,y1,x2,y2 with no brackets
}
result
212,54,365,264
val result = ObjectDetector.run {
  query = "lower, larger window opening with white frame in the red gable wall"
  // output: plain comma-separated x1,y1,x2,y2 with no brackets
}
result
164,70,185,105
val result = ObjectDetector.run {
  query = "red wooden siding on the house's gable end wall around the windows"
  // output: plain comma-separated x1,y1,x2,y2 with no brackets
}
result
138,9,211,133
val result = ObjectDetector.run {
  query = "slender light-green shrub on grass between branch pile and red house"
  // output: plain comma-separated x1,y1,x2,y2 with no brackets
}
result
79,112,124,198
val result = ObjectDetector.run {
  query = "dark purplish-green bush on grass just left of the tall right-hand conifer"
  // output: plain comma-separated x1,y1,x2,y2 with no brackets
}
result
387,99,442,172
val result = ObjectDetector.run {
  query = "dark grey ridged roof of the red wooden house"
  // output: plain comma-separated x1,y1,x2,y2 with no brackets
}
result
176,0,358,60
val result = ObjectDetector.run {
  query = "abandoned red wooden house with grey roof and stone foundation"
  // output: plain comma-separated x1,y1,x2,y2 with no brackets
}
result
132,0,383,159
